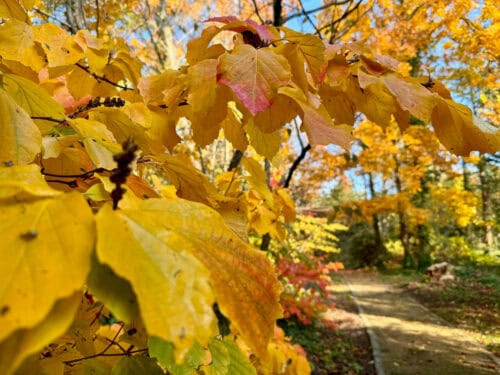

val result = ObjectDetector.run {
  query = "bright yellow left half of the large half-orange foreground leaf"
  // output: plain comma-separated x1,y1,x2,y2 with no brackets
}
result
96,206,216,358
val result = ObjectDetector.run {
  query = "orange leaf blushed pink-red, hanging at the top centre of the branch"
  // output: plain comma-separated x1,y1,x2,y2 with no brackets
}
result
218,44,291,115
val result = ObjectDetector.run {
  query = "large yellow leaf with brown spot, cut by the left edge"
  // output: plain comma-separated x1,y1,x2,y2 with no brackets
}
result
0,193,95,339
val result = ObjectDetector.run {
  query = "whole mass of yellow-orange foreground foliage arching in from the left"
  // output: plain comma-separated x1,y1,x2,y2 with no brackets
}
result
0,0,500,374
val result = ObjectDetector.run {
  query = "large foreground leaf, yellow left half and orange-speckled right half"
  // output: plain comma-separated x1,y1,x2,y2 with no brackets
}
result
97,199,281,362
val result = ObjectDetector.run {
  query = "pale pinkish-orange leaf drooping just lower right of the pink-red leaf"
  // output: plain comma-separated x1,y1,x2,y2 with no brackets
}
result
280,87,353,150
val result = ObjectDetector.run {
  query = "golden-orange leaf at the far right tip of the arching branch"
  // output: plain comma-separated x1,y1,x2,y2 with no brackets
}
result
432,97,500,155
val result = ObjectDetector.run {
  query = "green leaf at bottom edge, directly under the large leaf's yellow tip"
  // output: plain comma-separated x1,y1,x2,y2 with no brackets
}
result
148,336,205,375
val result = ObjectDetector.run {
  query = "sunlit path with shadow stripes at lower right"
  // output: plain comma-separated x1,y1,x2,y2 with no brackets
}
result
343,271,500,375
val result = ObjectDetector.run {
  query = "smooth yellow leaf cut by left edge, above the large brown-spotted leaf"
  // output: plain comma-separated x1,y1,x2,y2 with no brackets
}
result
0,89,42,165
